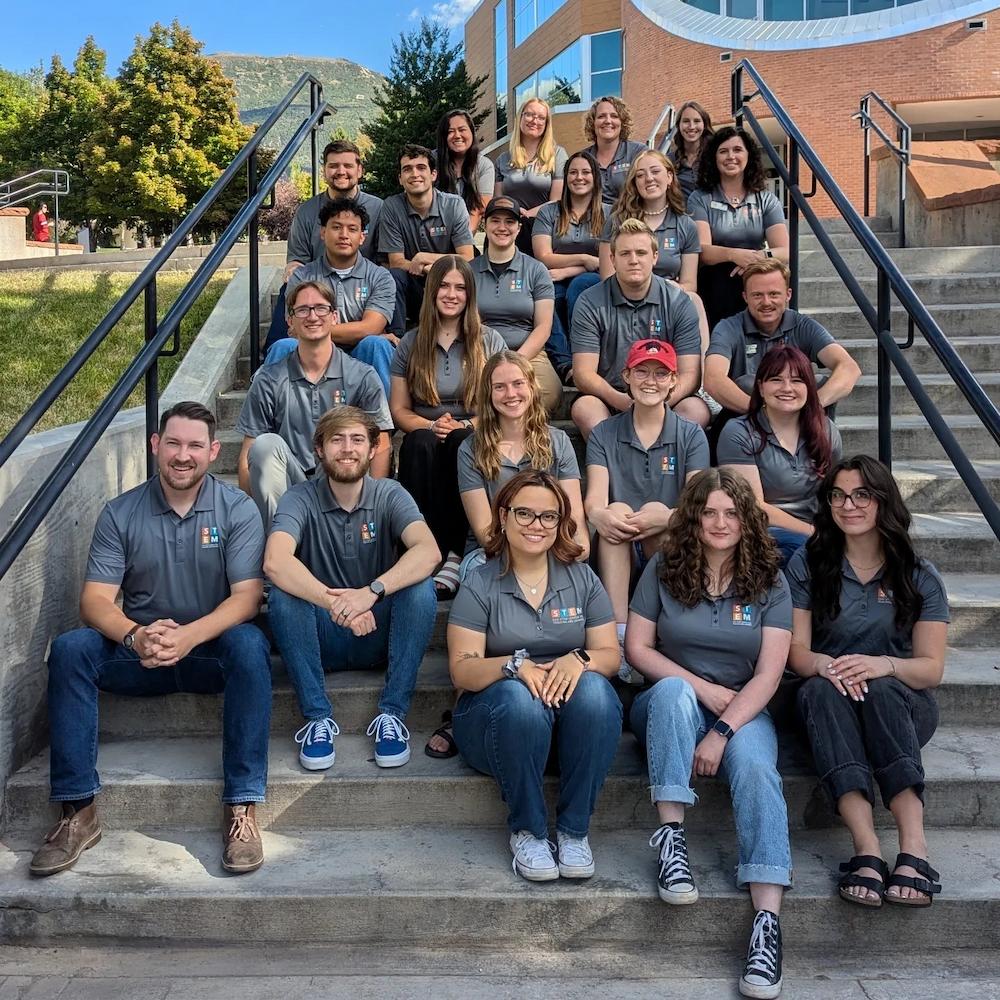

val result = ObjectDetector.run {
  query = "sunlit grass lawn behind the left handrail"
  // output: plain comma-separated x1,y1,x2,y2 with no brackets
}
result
0,271,232,436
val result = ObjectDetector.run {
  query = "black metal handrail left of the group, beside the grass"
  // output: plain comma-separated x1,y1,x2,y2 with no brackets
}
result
0,73,334,578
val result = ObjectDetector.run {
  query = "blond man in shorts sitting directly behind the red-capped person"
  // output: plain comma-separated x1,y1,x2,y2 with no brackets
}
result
571,219,709,438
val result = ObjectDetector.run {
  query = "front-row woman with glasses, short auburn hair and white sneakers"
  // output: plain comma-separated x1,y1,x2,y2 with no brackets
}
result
448,469,622,882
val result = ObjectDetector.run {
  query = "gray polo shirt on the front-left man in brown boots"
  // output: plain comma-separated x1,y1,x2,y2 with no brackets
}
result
85,475,264,625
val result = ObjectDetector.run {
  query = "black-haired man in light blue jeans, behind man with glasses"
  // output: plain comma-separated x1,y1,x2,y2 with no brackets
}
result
265,198,399,396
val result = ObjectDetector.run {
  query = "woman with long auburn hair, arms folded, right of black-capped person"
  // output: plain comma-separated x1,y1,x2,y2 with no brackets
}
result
531,152,605,385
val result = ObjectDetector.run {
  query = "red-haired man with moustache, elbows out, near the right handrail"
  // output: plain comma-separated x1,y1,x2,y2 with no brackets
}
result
705,257,861,413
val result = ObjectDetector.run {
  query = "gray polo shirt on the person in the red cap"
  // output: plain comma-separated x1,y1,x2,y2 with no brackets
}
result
587,407,712,510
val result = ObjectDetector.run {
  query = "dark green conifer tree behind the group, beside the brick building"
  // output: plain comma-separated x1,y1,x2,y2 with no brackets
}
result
363,18,487,198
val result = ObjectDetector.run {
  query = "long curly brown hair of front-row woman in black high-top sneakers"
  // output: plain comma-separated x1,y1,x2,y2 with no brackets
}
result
660,469,779,608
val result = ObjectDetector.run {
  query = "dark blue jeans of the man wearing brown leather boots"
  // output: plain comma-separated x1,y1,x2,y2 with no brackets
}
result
49,624,271,802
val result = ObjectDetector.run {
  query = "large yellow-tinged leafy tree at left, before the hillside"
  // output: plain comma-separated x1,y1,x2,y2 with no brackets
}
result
83,21,251,235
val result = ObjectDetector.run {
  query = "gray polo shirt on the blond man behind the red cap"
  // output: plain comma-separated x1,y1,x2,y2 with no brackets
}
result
571,274,701,392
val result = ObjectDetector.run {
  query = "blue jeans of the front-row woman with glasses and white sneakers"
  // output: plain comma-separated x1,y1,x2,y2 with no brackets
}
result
452,671,622,838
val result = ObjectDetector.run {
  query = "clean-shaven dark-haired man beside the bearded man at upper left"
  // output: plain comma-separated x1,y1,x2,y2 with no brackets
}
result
378,145,473,336
